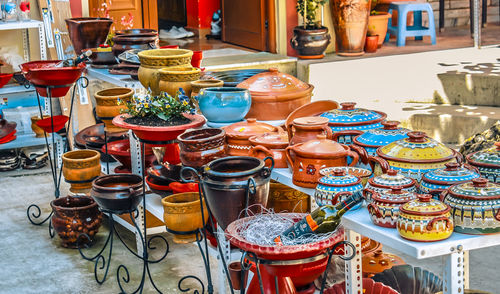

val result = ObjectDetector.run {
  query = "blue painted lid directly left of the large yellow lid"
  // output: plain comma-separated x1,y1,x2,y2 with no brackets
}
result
354,121,411,147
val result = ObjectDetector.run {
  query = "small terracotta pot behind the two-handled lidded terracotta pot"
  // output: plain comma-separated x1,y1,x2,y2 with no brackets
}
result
287,116,333,146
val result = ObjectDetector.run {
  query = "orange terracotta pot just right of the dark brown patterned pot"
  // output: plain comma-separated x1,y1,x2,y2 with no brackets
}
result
223,118,283,156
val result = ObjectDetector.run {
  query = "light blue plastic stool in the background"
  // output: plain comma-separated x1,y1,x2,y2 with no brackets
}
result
385,2,436,46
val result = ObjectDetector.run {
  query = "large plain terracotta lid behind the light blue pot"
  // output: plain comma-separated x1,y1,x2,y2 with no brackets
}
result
237,68,312,96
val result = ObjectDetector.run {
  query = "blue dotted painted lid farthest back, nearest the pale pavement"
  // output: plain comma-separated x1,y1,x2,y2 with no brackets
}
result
320,102,387,126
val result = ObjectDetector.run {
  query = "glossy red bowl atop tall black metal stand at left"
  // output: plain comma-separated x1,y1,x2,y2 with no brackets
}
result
21,60,85,97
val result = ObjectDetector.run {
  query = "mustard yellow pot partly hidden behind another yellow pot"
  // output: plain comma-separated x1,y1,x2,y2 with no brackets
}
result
137,49,193,95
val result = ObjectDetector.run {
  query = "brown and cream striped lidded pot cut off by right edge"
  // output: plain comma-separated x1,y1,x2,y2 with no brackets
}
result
442,178,500,235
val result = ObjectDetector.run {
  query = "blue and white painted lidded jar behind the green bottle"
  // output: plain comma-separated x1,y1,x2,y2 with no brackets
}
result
314,169,363,209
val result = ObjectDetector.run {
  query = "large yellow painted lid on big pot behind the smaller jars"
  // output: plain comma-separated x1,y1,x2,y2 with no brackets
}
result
377,132,455,163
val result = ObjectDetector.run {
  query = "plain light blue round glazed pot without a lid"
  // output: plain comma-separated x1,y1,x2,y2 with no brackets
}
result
197,87,252,123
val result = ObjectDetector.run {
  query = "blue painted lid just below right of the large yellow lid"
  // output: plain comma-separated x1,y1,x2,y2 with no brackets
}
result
422,162,481,185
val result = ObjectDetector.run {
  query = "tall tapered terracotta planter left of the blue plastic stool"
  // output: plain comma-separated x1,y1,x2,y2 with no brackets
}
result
330,0,370,56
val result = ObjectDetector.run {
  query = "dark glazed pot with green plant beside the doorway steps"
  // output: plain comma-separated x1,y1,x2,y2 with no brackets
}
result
290,0,331,59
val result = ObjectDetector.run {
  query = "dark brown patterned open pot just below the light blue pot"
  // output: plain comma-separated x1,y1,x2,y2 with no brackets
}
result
177,128,227,168
